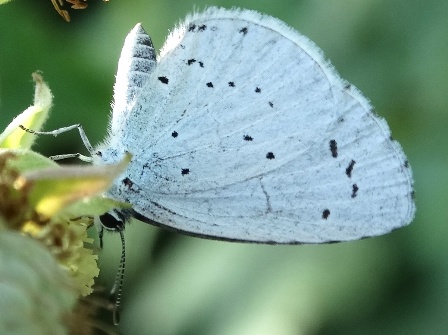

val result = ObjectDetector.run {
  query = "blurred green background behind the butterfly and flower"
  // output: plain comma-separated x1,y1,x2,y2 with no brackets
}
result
0,0,448,335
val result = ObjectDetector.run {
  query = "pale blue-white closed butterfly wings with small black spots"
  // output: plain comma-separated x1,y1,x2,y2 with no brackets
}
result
97,8,415,243
